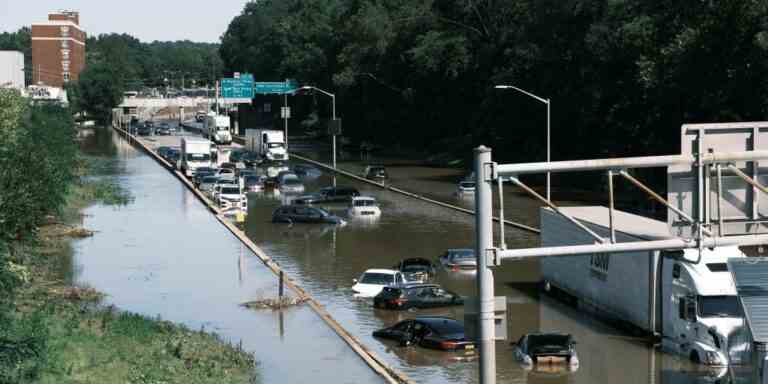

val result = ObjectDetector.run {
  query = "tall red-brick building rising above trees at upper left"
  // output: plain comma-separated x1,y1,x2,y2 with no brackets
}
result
30,11,86,87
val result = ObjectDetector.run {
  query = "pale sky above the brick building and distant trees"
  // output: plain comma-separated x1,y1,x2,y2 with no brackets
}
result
0,0,247,43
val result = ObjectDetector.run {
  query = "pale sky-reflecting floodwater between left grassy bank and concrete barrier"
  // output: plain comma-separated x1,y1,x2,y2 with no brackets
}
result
73,129,382,383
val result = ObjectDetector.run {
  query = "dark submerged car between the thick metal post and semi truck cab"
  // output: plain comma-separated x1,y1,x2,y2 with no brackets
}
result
512,332,579,370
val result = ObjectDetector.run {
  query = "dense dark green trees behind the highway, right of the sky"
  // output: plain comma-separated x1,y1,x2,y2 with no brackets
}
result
220,0,768,161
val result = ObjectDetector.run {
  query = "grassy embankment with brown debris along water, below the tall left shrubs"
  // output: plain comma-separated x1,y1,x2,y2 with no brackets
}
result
10,158,258,384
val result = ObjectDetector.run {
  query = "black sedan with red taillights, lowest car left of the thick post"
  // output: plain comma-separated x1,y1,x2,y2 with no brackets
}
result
373,316,475,351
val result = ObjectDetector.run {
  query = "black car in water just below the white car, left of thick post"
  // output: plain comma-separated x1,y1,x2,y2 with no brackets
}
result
373,284,464,310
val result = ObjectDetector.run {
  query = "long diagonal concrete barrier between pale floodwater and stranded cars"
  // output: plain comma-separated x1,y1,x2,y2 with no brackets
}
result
113,126,415,384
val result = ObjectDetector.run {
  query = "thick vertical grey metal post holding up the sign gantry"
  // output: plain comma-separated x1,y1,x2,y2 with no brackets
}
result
475,146,496,384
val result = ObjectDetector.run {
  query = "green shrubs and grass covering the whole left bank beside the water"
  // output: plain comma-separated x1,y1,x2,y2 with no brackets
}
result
0,89,257,384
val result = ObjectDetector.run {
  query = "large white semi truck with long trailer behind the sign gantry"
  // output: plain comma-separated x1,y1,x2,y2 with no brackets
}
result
540,206,746,366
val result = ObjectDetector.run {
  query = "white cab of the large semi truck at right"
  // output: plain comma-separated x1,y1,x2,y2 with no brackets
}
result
661,246,746,366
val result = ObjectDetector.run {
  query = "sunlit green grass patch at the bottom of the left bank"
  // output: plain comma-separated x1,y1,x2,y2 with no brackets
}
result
39,304,258,384
